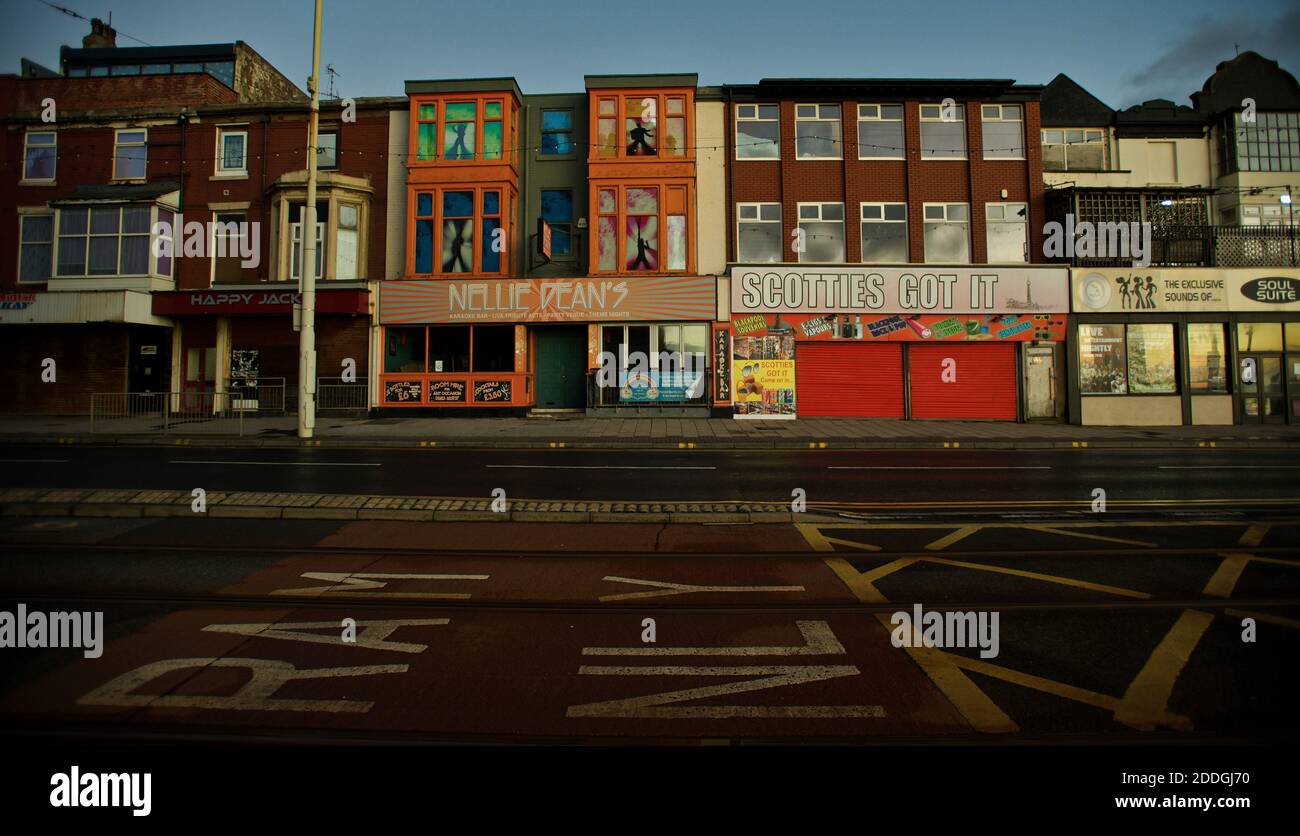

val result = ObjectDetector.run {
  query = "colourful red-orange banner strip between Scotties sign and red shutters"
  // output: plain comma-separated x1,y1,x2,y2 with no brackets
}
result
732,313,1066,342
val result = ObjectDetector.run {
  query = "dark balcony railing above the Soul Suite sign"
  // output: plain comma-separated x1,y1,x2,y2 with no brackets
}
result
1071,225,1300,267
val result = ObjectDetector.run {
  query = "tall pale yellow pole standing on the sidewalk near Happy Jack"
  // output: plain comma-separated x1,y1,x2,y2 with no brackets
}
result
298,0,321,438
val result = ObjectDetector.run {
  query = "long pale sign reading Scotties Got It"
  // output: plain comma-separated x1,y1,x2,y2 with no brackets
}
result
731,264,1070,315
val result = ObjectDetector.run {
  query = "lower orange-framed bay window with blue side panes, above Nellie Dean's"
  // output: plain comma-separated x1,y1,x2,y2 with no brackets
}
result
412,186,510,274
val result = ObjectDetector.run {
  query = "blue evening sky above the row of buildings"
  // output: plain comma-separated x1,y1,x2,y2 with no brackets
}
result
0,0,1300,108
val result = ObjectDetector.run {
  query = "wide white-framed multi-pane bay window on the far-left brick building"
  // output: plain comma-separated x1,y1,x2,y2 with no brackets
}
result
59,205,152,276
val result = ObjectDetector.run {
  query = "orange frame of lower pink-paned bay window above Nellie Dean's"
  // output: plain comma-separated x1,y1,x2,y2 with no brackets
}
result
588,178,696,276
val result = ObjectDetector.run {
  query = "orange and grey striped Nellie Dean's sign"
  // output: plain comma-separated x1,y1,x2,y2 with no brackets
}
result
380,276,718,325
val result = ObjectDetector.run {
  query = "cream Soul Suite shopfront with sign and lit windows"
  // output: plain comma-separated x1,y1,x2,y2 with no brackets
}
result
1070,268,1300,425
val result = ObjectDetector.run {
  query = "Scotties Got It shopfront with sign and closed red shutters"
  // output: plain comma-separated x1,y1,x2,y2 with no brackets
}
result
731,265,1069,421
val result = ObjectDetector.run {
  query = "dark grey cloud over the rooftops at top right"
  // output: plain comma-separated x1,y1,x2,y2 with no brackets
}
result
1121,8,1300,107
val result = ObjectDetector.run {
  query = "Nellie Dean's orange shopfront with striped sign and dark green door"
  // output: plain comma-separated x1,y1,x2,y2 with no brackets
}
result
377,277,718,415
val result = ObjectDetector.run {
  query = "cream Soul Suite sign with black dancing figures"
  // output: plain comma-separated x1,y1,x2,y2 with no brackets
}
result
1071,268,1300,313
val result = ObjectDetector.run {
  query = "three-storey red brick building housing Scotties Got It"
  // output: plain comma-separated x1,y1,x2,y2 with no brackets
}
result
718,79,1069,420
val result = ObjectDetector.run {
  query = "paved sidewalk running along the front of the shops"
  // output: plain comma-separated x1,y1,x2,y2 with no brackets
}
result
0,416,1300,450
